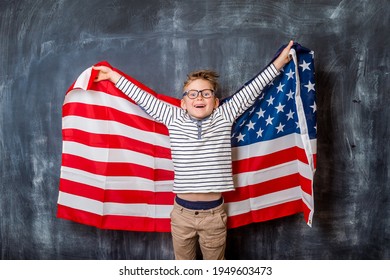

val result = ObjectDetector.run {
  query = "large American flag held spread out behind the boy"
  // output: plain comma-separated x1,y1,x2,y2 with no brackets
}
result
57,44,316,232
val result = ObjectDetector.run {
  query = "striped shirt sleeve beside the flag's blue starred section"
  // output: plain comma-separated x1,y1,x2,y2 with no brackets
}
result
220,63,280,123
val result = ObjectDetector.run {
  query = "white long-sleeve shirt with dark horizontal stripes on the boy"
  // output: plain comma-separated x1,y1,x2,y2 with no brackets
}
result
116,64,279,193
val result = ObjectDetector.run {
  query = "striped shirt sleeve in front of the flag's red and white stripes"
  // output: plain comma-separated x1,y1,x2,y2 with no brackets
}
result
115,76,175,125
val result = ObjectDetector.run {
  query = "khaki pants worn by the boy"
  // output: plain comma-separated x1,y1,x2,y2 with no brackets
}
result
171,201,227,260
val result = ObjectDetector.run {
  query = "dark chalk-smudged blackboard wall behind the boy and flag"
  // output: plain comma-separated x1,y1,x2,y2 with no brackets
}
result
0,0,390,259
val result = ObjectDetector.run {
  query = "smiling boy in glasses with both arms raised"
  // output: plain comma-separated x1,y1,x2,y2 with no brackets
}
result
94,41,293,260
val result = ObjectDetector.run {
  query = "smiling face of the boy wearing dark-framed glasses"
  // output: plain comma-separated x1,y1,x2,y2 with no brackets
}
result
181,79,219,120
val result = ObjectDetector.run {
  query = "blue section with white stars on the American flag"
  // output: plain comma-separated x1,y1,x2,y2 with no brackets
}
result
225,43,317,147
